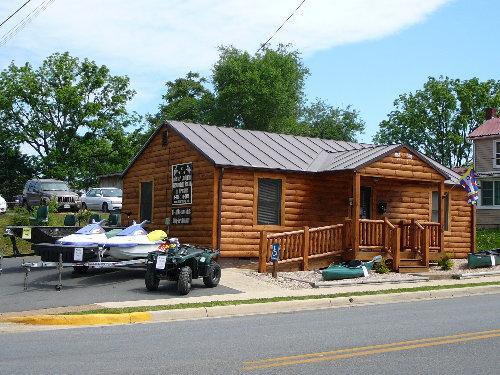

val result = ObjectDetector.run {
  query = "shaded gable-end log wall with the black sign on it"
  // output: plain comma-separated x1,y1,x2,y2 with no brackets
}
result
122,127,217,246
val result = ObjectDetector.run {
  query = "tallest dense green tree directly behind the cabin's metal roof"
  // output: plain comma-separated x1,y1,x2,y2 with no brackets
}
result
212,46,308,132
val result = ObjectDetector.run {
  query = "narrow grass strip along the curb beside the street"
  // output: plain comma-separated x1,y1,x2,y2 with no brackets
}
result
66,281,500,315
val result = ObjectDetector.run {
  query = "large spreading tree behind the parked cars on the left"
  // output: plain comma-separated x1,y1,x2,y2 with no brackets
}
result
0,52,135,184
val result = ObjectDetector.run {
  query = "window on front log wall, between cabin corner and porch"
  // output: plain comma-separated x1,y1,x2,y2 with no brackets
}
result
257,178,281,225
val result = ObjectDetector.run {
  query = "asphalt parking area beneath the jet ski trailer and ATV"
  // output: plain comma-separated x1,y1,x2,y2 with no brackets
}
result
0,257,239,312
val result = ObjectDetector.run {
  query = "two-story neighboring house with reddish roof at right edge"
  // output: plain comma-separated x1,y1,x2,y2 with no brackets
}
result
468,108,500,228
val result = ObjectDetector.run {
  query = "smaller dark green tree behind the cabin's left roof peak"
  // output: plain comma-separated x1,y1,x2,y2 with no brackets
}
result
148,72,214,125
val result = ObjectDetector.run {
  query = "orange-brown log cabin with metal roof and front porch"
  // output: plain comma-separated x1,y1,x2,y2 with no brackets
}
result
122,121,475,272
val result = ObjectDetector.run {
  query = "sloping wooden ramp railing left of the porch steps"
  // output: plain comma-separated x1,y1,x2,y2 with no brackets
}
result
259,224,345,272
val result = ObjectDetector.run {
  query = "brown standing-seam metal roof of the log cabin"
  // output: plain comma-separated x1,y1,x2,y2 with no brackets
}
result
123,121,460,183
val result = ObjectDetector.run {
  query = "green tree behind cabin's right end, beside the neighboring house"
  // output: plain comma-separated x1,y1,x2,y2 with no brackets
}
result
374,77,500,167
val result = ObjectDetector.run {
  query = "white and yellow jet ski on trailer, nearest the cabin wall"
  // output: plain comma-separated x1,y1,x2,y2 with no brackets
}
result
102,221,167,260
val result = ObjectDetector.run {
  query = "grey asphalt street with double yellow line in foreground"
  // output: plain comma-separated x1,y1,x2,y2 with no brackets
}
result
0,294,500,375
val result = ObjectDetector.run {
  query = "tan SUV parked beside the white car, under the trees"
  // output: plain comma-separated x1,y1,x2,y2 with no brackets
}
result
23,179,81,211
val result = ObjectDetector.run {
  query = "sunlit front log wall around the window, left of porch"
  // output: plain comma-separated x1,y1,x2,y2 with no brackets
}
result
221,168,351,257
